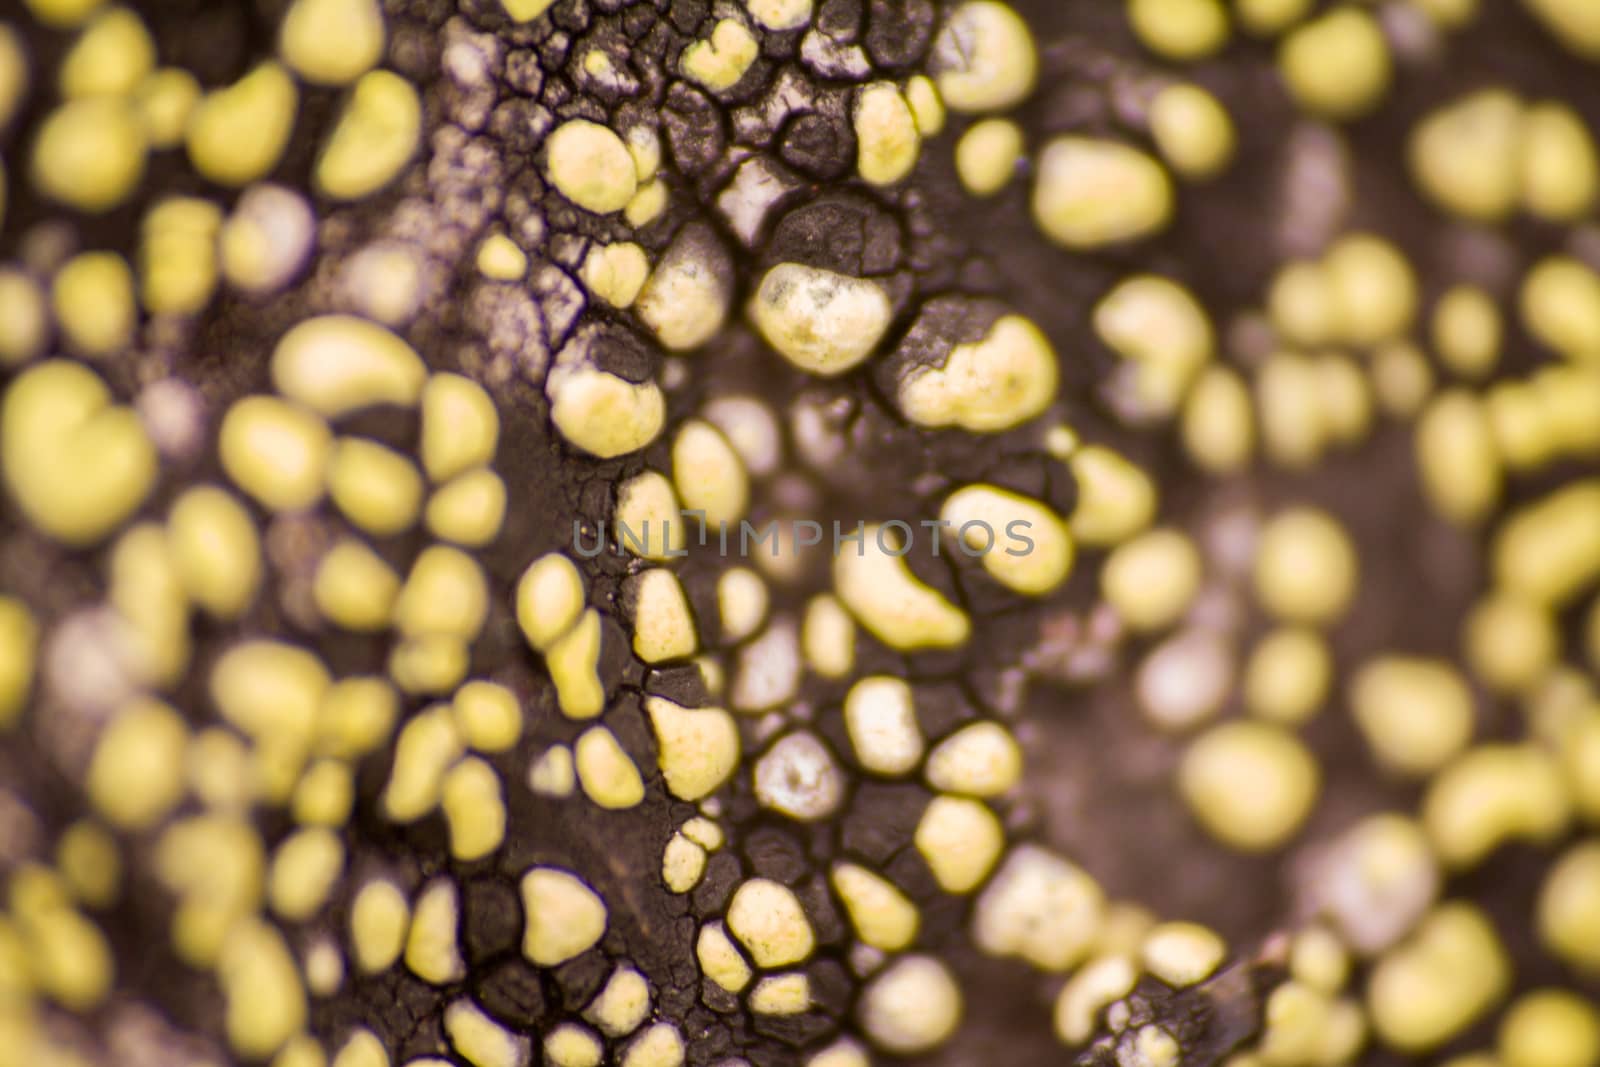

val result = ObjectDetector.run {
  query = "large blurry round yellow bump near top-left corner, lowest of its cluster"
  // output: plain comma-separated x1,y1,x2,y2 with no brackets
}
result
29,96,144,213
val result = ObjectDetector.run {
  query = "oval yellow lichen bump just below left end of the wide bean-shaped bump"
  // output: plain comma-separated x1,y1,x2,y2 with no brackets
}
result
218,397,333,512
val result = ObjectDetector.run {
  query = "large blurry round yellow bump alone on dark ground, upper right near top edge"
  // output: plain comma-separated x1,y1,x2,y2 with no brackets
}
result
1278,6,1390,120
